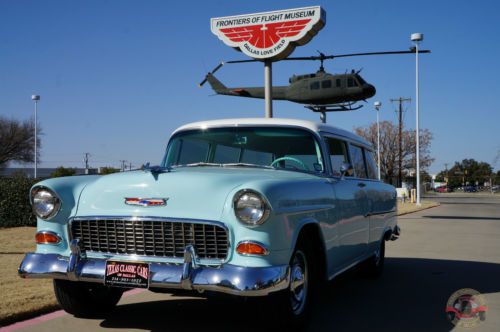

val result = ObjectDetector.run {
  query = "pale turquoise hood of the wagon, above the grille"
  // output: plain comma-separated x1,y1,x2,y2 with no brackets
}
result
76,167,311,220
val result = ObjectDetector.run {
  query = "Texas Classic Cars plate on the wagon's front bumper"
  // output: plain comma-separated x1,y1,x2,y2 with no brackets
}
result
104,261,149,288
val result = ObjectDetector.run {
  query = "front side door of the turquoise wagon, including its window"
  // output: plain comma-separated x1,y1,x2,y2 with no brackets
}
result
325,136,368,275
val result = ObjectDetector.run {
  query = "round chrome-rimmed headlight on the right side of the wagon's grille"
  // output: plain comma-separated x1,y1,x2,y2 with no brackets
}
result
234,190,269,226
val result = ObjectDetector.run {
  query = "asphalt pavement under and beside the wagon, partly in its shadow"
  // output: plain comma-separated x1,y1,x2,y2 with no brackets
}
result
8,194,500,331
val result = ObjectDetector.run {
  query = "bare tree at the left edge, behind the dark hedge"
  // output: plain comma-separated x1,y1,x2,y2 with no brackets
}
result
0,116,41,168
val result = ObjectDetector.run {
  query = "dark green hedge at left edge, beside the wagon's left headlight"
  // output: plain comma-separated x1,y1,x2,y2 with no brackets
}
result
0,175,40,228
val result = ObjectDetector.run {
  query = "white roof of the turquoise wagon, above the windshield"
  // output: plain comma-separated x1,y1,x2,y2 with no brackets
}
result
173,118,372,147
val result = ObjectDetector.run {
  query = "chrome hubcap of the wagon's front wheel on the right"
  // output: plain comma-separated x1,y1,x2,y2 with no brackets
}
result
290,250,307,315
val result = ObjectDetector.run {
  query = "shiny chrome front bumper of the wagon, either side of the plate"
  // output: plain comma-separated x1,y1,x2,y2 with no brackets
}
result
19,240,290,296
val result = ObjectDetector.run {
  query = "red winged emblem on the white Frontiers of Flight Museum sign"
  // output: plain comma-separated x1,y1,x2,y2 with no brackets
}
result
220,19,311,49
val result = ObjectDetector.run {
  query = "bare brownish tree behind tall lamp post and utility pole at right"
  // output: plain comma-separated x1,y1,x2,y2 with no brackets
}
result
354,121,434,182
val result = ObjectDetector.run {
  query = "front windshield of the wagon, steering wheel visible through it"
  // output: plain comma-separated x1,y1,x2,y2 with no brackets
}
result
162,127,324,173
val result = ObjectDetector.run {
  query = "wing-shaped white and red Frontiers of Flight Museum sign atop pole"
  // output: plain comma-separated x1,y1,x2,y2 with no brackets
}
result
210,6,326,61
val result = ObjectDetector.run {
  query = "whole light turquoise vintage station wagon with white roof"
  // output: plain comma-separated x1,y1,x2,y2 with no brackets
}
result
19,119,400,321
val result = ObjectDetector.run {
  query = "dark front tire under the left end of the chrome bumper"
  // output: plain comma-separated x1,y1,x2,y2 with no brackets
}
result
54,279,124,318
